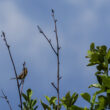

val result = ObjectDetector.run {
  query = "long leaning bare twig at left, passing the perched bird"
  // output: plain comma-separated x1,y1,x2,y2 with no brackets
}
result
1,32,22,110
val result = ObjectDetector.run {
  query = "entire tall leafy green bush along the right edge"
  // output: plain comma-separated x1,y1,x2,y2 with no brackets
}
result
84,43,110,110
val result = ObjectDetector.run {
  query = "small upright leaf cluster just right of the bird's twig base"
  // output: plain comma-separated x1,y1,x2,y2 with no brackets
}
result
22,89,38,110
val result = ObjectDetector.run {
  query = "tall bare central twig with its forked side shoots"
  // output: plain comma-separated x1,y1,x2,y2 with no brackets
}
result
37,9,61,110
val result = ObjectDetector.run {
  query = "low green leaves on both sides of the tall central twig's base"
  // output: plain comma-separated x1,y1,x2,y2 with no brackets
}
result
41,92,88,110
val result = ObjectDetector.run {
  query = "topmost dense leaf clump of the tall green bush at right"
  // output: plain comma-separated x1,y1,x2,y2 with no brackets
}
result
86,43,110,72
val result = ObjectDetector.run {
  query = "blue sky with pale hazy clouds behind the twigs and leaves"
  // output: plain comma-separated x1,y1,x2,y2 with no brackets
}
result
0,0,110,110
